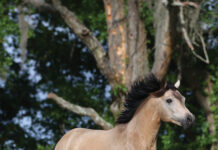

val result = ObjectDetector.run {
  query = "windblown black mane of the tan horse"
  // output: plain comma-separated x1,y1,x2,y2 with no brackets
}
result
116,74,176,124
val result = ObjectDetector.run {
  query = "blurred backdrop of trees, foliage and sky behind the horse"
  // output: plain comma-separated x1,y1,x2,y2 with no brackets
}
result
0,0,218,150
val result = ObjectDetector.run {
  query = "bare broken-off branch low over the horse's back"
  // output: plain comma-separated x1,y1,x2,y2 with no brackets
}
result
48,93,113,129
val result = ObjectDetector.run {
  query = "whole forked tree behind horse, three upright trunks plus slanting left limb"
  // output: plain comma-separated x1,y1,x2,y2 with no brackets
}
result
23,0,173,122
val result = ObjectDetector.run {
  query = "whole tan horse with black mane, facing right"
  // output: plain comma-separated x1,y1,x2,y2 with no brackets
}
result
55,74,195,150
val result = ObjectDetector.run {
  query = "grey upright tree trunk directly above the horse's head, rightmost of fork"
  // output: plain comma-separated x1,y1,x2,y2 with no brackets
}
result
152,0,177,80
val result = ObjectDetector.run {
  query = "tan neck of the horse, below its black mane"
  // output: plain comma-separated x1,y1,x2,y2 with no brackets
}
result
127,98,160,150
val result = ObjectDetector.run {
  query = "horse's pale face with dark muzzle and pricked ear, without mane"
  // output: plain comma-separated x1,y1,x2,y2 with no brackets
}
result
154,81,195,129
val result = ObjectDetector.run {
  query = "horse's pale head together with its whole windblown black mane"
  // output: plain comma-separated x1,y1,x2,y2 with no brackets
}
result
117,74,195,128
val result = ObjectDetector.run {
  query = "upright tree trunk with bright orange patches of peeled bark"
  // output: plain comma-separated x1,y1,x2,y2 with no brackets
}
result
104,0,127,88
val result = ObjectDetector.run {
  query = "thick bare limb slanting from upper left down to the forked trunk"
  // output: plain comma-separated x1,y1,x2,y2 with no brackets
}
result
52,0,113,82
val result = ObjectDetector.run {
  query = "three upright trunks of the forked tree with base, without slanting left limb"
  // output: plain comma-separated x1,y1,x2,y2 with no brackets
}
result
104,0,176,117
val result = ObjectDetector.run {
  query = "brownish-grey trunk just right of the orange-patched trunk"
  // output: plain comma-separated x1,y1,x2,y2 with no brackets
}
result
126,0,149,88
